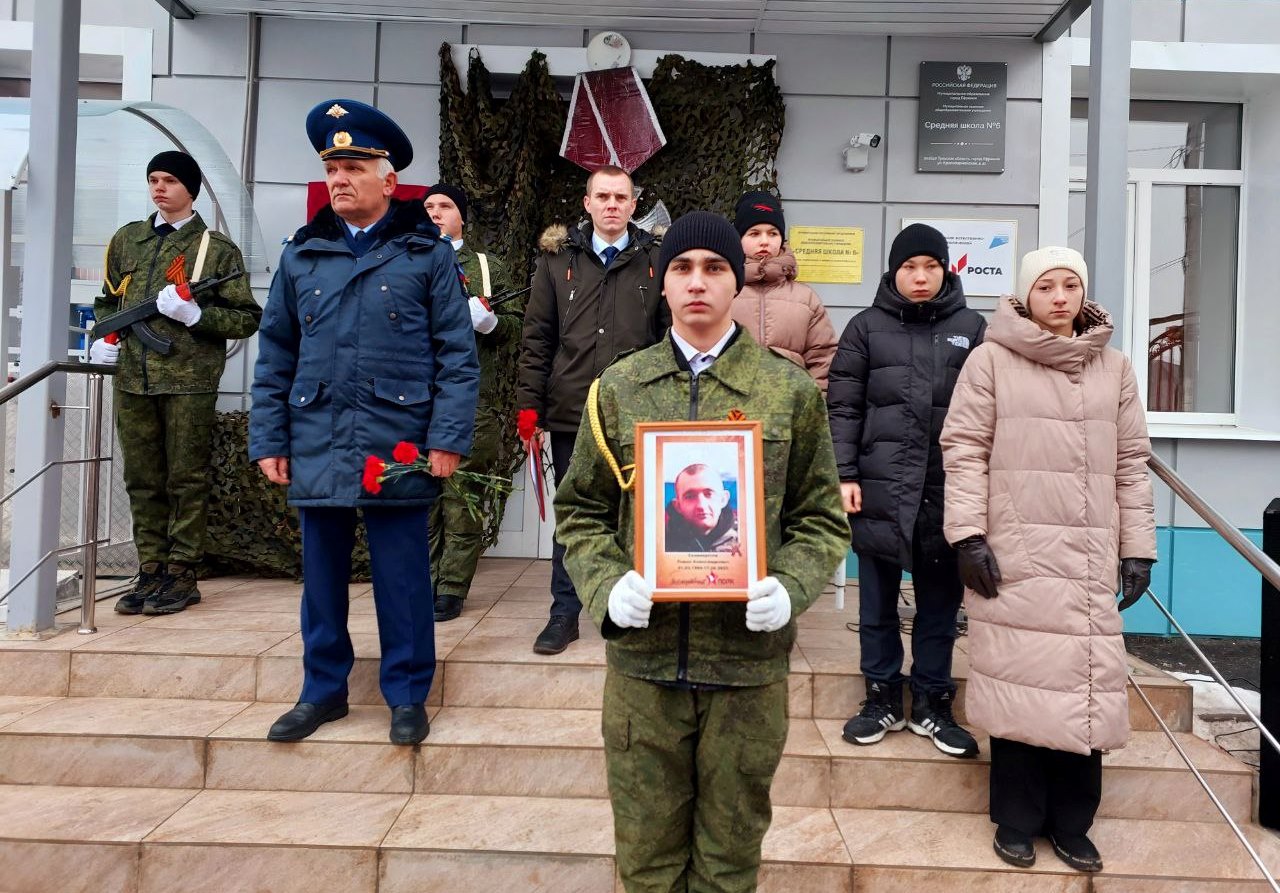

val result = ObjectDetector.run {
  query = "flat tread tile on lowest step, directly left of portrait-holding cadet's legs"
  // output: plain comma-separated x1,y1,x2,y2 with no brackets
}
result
383,794,613,856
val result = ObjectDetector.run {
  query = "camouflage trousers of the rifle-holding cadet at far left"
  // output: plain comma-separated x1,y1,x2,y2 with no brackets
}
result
114,389,218,565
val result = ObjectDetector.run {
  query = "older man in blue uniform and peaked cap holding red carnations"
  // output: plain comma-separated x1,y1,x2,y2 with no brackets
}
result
250,100,480,745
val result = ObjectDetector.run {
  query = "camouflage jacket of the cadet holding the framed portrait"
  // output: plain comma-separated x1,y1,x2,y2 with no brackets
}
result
556,328,849,686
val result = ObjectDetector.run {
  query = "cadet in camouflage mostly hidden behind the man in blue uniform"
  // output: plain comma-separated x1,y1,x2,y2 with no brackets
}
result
422,183,525,623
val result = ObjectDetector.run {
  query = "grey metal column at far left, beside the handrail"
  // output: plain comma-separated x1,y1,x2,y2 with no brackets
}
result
8,0,81,632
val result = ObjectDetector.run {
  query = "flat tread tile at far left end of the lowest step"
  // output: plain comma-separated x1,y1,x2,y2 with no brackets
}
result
0,784,196,843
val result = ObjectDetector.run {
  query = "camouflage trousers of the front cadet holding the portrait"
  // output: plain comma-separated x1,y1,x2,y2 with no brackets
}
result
602,667,787,893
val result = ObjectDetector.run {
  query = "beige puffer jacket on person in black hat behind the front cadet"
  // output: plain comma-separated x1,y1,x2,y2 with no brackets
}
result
732,251,836,394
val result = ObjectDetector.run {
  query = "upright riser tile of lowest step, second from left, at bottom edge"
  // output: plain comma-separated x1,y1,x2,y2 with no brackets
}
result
143,843,378,893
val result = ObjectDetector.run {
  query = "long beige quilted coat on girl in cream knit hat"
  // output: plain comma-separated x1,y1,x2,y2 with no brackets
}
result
942,297,1156,754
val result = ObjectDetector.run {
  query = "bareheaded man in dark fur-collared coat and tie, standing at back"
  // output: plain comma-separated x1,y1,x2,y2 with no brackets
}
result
516,166,671,654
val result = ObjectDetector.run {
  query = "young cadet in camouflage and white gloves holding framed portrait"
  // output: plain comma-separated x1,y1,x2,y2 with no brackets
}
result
556,211,849,893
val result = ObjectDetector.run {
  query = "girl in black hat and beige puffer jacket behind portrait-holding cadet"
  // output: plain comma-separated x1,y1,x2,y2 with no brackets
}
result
732,192,836,394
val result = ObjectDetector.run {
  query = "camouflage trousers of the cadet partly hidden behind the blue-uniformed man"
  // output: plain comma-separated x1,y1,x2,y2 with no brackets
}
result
428,407,502,599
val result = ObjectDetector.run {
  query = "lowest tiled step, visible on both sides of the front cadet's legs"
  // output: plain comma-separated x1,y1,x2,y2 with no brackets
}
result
0,786,1280,893
